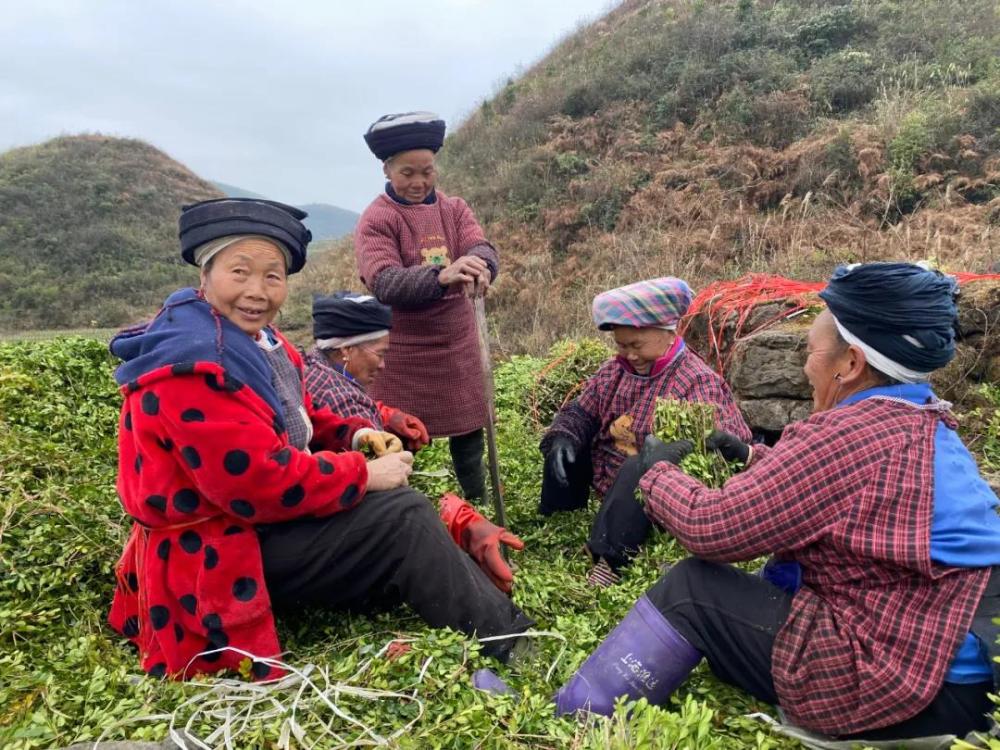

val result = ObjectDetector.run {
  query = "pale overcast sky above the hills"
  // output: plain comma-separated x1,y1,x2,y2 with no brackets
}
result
0,0,615,211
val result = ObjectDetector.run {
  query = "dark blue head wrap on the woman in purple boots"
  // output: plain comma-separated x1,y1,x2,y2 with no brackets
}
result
819,263,958,373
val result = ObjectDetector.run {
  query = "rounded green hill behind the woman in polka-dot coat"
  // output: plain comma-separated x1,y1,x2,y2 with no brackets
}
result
0,135,221,330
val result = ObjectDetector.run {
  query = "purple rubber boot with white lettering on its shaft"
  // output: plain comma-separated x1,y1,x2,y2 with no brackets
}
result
556,596,701,716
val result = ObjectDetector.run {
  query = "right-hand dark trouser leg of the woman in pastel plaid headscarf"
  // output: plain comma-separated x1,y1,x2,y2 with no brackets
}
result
587,456,653,572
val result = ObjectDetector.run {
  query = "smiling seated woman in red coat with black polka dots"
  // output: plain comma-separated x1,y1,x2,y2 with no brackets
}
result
109,199,531,679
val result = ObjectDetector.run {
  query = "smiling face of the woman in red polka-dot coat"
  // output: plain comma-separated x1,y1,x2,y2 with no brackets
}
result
201,238,288,338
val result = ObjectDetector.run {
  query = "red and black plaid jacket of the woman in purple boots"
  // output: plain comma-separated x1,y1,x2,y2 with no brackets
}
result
641,399,989,733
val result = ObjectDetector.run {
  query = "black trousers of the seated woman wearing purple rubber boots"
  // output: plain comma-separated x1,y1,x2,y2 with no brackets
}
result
646,558,1000,740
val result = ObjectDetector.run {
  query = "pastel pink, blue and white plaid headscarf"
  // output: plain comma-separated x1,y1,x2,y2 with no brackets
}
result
593,276,694,331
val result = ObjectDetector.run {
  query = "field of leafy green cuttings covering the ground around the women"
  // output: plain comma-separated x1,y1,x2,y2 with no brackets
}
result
0,337,1000,750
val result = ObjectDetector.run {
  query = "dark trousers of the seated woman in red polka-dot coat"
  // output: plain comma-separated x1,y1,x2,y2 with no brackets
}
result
258,487,532,660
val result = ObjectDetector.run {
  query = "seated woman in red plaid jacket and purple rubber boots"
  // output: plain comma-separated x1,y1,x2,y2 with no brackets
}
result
557,263,1000,740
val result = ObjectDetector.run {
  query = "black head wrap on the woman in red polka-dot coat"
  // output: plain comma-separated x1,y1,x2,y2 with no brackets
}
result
179,198,312,273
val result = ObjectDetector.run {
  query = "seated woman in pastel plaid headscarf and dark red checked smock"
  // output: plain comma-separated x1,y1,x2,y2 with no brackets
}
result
539,277,750,586
